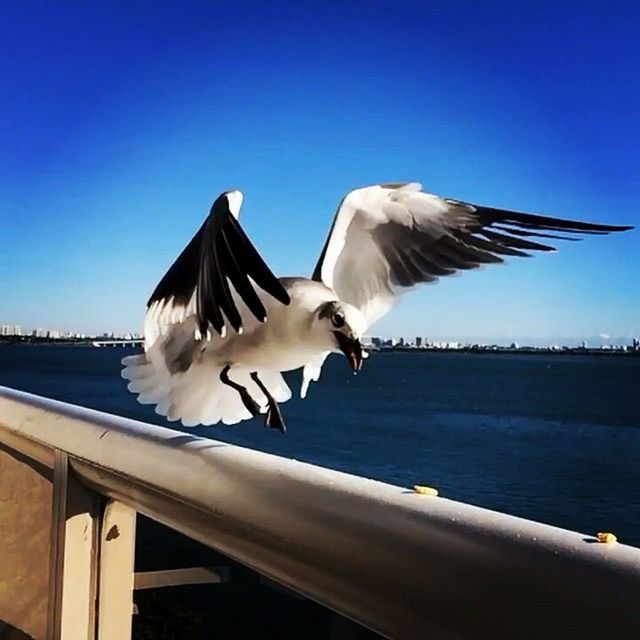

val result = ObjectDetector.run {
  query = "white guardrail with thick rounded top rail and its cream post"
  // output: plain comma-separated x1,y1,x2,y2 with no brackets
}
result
0,387,640,640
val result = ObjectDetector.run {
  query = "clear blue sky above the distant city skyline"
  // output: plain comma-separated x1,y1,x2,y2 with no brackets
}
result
0,0,640,341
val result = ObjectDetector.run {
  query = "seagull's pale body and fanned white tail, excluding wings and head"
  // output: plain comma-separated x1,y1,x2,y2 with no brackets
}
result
123,278,365,426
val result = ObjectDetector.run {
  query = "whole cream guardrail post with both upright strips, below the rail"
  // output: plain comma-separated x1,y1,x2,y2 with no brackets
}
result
47,451,136,640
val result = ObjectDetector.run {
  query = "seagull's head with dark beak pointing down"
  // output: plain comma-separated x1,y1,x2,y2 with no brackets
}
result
317,300,367,372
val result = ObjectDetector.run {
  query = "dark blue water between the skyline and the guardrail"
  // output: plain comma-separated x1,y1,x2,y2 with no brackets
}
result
0,345,640,546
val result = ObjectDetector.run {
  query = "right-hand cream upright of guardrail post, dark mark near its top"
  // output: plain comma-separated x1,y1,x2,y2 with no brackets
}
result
98,500,136,640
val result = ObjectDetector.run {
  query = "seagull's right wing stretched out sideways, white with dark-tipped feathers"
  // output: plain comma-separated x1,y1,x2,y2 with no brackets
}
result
312,183,632,324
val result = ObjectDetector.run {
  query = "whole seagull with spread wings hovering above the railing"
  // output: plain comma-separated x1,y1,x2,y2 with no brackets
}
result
122,182,633,433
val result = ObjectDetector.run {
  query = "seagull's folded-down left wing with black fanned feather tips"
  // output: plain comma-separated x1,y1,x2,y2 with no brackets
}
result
145,191,289,348
